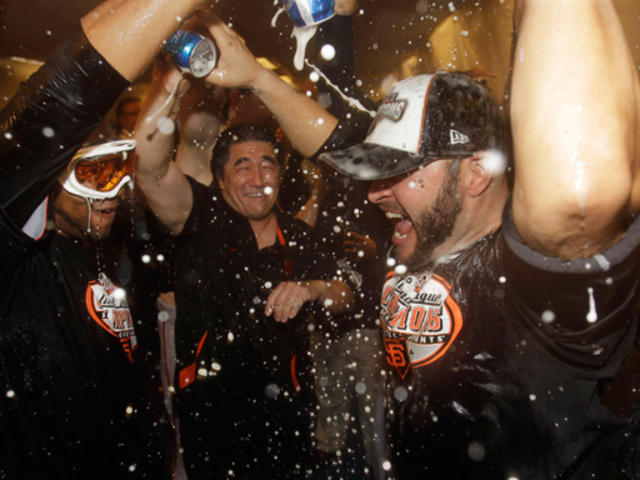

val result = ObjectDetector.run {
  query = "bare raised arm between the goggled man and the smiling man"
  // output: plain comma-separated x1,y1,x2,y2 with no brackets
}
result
135,58,193,234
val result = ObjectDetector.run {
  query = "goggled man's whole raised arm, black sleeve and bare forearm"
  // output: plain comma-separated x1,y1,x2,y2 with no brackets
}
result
0,0,208,225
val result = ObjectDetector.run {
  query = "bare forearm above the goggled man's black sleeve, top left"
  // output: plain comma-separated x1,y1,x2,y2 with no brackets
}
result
82,0,203,81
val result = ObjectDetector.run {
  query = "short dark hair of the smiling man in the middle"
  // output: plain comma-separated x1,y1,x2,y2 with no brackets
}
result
211,125,283,179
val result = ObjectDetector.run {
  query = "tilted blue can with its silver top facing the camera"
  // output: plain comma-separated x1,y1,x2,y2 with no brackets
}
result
163,30,218,78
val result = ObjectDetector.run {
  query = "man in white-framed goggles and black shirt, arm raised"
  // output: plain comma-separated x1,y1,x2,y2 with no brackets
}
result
0,0,212,479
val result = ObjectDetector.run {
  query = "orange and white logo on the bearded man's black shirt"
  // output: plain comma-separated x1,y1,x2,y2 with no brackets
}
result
381,274,463,378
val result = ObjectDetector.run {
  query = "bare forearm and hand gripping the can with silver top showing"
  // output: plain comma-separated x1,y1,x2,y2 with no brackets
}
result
201,15,338,157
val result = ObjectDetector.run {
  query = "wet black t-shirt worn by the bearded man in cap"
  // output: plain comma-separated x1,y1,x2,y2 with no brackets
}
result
381,202,640,480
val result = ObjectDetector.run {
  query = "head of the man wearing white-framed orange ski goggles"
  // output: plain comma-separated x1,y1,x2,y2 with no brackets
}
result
54,140,136,240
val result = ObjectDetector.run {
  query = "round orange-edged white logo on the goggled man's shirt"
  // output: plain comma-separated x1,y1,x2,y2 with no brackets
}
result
85,273,138,363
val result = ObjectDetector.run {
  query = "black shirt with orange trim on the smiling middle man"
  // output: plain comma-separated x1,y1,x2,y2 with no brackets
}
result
174,178,338,479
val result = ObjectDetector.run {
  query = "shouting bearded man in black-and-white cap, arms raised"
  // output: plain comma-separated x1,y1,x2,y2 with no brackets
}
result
196,0,640,480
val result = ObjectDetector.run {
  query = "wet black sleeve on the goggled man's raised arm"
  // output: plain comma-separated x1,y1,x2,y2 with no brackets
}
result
0,30,129,226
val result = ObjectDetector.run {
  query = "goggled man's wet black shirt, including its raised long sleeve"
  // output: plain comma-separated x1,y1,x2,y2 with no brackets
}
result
0,34,165,479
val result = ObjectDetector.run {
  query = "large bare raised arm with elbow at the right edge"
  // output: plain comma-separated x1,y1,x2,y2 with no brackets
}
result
511,0,640,258
